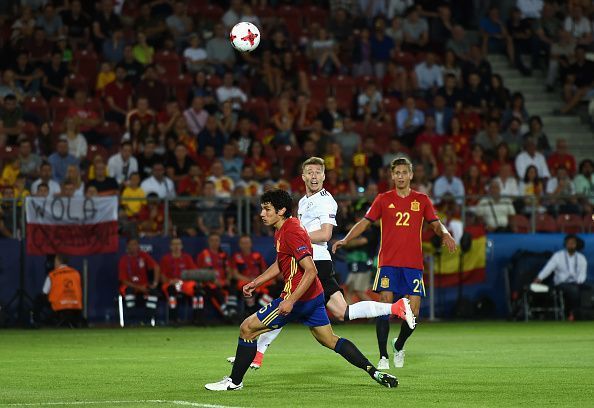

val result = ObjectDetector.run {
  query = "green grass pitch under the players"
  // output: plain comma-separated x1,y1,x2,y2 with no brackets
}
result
0,322,594,408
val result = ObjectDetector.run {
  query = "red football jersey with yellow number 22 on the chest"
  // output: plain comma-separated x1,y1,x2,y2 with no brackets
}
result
365,190,439,270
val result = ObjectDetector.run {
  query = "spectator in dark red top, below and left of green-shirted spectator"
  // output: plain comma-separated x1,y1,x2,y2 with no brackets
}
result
103,64,133,126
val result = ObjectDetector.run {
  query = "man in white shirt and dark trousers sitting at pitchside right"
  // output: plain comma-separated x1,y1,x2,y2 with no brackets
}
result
534,235,592,320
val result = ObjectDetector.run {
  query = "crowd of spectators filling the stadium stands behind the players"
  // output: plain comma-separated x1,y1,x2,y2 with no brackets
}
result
0,0,594,241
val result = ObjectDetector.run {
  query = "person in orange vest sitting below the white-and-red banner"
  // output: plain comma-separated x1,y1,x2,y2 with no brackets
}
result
32,254,84,327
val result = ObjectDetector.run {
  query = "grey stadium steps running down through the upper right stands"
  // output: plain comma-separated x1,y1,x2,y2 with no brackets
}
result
488,55,594,163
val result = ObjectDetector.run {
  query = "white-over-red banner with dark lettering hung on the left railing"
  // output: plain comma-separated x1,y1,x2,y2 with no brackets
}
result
25,196,118,256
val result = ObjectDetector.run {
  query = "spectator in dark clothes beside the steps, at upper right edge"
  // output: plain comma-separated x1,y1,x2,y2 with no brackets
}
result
555,45,594,115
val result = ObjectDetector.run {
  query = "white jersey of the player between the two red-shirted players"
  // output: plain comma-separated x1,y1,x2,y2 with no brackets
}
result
297,189,338,261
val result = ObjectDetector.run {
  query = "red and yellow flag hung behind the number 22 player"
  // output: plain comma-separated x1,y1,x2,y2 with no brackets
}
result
423,227,487,288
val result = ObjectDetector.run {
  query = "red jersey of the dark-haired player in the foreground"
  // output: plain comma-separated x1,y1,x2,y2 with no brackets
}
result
274,217,323,300
